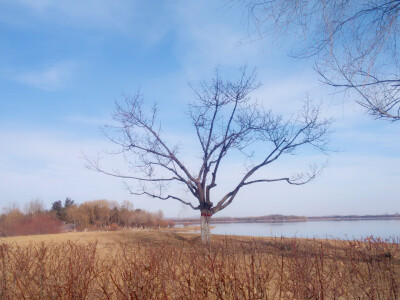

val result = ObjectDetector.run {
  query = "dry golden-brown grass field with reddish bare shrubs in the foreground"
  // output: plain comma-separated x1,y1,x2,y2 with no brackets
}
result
0,230,400,300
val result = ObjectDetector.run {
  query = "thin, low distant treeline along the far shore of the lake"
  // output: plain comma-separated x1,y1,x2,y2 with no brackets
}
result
172,213,400,225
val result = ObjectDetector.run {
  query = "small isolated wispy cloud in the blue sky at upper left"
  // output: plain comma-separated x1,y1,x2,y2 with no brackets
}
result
13,62,77,91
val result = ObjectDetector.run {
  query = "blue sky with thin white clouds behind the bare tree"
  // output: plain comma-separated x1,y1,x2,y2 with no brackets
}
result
0,0,400,217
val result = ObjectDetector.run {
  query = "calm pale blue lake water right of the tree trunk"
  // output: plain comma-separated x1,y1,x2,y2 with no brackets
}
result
211,220,400,240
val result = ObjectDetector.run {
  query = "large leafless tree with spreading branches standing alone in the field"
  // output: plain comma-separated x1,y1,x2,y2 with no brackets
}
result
88,68,330,243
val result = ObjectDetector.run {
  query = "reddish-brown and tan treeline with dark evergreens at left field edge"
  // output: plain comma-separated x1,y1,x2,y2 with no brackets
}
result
0,198,173,236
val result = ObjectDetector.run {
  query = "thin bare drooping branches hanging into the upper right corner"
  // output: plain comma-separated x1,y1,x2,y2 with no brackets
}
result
240,0,400,122
